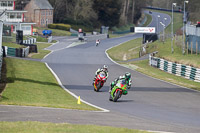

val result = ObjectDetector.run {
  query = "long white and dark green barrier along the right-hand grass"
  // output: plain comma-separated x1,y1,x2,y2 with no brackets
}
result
149,55,200,82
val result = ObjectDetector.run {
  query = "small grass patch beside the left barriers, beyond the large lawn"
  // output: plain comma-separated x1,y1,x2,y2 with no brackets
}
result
30,43,52,59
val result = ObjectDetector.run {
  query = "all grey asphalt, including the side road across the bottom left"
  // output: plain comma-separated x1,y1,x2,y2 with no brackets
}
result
0,13,200,133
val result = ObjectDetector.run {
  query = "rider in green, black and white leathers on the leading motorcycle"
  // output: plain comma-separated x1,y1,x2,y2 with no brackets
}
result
109,72,131,95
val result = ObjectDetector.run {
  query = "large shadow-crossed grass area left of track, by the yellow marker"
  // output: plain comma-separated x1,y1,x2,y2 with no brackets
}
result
0,58,97,110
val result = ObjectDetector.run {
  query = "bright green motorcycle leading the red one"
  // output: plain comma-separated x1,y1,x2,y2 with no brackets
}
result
109,79,127,102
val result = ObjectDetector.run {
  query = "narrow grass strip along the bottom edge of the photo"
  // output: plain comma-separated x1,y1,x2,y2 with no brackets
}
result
0,122,149,133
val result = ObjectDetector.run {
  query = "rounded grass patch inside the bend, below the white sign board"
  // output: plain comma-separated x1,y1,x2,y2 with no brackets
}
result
107,38,142,61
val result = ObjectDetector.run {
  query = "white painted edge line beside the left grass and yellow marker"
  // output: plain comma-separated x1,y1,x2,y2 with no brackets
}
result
45,63,110,112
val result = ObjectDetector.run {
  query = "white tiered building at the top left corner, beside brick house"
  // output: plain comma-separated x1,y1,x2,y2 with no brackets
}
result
0,0,35,35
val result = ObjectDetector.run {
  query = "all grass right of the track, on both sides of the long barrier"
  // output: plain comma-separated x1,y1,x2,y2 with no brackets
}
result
107,9,200,90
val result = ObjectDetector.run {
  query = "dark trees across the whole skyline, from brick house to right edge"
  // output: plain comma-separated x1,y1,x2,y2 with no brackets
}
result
16,0,200,27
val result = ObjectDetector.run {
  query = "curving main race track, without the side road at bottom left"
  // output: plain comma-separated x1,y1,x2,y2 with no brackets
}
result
44,13,200,133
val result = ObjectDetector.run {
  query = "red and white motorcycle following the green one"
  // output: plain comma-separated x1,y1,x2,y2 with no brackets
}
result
93,72,106,92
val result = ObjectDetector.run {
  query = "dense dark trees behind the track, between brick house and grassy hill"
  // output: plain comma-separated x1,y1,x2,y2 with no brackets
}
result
49,0,151,27
